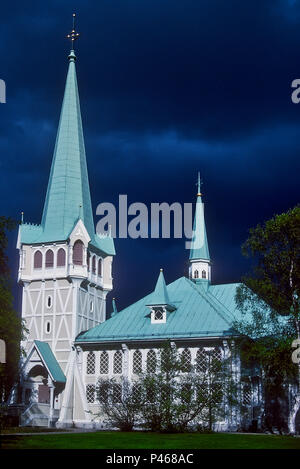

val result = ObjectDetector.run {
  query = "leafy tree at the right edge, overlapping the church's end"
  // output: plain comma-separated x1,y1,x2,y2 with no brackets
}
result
233,206,300,434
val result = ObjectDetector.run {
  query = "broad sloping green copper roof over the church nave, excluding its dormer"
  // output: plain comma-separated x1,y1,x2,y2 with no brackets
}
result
76,277,240,343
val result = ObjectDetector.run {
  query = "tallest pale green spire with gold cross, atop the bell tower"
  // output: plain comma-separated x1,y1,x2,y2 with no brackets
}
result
42,17,94,239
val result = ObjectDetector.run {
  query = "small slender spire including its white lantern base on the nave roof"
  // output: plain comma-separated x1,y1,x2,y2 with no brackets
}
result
190,173,210,280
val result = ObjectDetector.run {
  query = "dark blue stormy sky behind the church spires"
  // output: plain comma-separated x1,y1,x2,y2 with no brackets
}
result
0,0,300,310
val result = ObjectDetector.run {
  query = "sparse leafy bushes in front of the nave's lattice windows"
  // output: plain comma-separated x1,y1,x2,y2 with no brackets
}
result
97,343,233,432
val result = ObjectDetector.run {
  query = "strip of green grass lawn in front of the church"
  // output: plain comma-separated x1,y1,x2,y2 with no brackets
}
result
1,432,300,449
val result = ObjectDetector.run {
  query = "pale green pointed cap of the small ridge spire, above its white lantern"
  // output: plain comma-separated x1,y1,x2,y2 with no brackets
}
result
190,178,210,261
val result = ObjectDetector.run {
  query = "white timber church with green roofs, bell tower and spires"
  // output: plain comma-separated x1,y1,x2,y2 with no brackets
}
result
12,38,261,430
